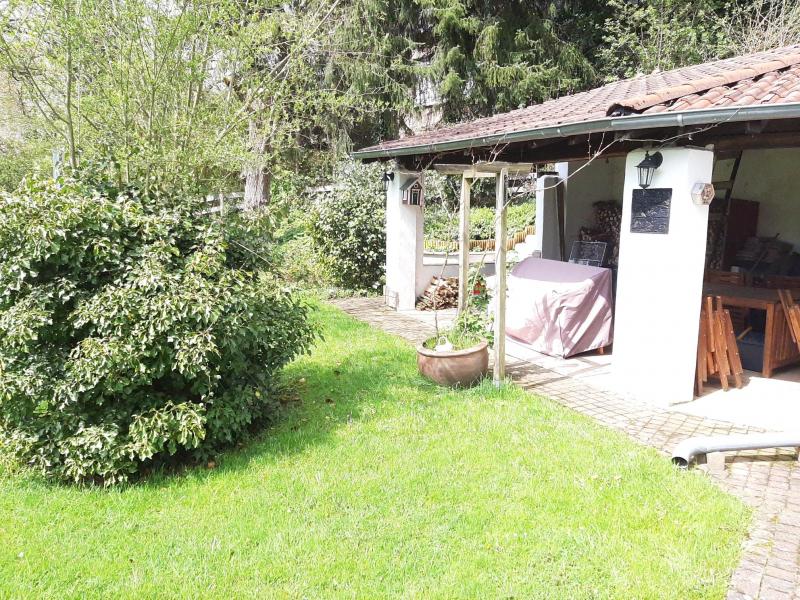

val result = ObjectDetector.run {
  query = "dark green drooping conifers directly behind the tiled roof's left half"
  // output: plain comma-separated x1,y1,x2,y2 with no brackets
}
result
342,0,608,145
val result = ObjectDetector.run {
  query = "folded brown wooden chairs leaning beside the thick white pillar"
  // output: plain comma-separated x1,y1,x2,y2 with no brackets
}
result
695,296,744,396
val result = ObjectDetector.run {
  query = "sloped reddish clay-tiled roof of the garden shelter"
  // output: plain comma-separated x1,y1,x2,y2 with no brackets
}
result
355,44,800,157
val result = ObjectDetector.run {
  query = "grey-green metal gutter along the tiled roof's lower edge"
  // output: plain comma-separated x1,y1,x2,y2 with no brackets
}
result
352,102,800,160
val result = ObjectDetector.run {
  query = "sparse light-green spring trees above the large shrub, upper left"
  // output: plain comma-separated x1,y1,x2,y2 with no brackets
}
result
0,0,388,191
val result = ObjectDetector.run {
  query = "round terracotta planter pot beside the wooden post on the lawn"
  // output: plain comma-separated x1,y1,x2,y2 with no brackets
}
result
417,342,489,387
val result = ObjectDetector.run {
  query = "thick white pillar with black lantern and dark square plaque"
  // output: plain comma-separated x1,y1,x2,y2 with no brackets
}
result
613,148,713,406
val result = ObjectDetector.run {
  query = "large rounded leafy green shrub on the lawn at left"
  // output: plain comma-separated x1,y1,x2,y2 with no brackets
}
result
0,181,313,483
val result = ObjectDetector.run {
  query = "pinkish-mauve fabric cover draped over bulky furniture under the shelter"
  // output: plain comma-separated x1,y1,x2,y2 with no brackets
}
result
506,257,613,358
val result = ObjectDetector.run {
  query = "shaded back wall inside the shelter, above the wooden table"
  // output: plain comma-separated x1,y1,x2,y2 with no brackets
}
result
728,148,800,252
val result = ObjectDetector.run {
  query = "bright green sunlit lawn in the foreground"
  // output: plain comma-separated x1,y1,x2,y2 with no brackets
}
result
0,307,749,598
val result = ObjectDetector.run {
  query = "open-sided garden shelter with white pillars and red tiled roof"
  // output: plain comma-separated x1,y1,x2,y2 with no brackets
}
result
356,48,800,429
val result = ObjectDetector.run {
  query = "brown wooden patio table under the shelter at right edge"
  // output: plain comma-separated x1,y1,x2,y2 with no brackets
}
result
703,283,800,377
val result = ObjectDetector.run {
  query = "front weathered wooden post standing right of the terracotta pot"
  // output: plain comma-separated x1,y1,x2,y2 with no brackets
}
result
492,169,508,386
